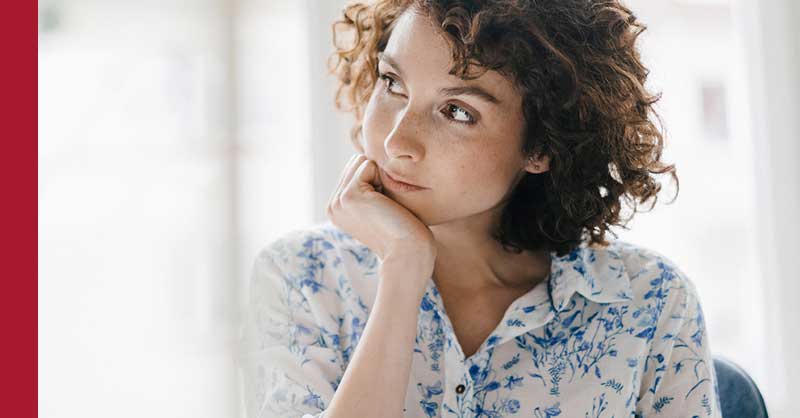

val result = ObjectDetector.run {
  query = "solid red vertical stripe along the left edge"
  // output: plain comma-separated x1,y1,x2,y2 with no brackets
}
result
0,0,38,417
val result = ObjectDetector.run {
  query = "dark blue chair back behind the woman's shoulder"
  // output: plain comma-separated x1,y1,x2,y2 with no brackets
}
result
714,355,768,418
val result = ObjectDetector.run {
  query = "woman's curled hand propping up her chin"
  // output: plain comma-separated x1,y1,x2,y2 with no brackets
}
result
327,154,436,269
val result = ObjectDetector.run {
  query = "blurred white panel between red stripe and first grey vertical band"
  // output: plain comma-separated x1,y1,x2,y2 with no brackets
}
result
38,0,239,418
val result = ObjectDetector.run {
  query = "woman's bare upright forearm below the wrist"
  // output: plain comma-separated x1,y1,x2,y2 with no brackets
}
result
325,265,428,418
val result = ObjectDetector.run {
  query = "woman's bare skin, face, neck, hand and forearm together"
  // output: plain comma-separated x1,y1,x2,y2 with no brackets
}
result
326,12,550,418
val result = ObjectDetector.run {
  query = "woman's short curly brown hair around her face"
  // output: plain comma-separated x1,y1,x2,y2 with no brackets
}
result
328,0,680,256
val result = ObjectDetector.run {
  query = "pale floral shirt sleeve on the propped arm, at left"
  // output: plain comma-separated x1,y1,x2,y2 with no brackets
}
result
237,250,344,418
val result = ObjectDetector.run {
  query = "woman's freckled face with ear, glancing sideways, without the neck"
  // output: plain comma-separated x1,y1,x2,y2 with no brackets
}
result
360,10,547,226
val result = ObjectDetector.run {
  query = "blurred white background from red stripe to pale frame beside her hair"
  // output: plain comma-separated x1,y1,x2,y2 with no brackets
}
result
38,0,322,418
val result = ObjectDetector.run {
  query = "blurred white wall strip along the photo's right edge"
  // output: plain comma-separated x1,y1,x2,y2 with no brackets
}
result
735,0,800,417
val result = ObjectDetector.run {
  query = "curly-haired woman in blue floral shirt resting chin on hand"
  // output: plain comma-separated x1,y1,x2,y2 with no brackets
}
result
236,0,720,418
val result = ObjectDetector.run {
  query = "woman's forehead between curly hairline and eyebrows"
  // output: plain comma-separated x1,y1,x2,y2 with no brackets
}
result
384,8,516,103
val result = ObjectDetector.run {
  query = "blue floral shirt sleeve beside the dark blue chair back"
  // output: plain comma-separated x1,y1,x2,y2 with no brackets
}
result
636,273,722,418
